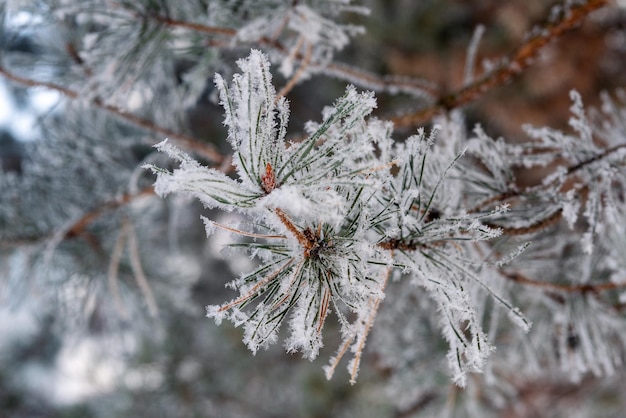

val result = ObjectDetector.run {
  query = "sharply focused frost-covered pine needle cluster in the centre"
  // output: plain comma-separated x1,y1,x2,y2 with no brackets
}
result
147,50,528,385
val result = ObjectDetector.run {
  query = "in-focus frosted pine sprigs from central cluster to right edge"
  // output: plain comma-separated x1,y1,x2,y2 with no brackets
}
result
146,44,626,386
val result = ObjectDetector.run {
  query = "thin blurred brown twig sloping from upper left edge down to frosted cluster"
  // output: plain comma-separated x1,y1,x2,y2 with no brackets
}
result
0,66,224,164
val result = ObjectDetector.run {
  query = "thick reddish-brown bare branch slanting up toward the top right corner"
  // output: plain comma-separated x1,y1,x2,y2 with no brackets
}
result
392,0,608,127
